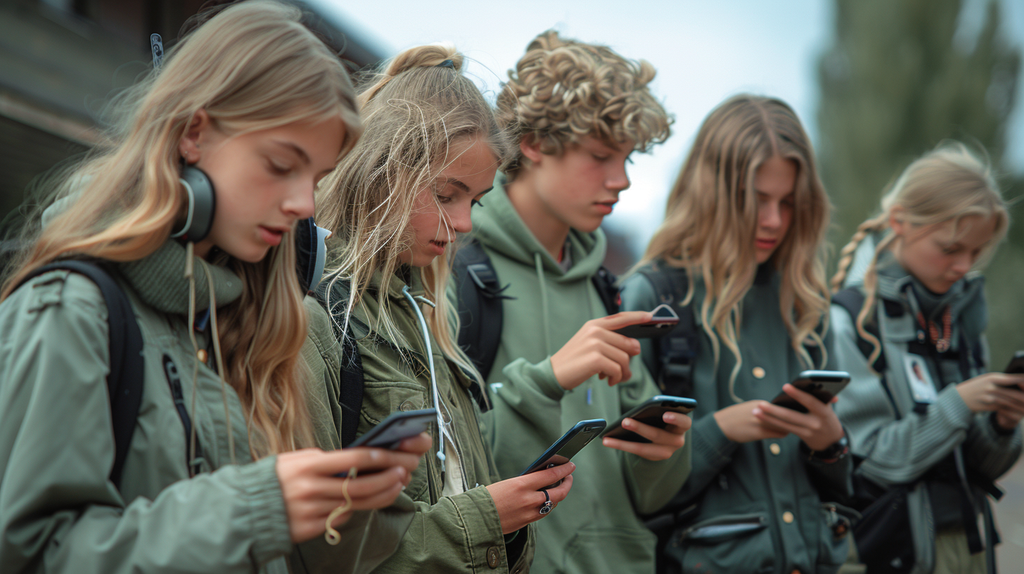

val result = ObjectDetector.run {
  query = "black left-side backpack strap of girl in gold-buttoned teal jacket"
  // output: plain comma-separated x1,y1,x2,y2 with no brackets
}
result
638,262,700,397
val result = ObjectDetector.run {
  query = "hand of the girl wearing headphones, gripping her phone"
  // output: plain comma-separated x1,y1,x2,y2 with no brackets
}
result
276,435,430,543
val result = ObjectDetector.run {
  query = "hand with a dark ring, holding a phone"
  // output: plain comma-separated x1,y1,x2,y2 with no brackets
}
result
486,462,575,534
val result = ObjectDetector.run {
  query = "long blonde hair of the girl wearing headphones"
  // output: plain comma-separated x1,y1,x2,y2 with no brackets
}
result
0,0,359,457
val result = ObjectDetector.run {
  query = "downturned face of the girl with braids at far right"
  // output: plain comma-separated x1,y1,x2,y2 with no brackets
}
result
889,208,995,294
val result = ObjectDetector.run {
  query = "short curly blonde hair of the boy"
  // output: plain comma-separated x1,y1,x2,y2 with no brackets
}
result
498,30,673,180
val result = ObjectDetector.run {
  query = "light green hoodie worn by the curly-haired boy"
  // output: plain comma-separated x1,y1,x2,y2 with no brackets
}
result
462,185,689,574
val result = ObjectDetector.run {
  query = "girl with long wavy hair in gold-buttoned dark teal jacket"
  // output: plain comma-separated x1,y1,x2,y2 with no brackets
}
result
622,95,851,573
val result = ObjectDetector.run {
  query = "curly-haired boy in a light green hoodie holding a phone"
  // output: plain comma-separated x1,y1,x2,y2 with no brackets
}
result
460,32,689,573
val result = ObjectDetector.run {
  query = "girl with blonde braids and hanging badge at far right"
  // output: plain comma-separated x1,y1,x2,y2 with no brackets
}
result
831,144,1024,573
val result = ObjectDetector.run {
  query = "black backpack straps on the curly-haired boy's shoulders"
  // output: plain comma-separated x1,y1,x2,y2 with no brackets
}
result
452,237,621,411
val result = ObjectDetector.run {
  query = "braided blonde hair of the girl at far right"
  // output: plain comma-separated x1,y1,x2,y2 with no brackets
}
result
831,141,1010,364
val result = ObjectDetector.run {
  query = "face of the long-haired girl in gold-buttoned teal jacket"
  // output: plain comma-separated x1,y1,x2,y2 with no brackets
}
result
754,156,797,264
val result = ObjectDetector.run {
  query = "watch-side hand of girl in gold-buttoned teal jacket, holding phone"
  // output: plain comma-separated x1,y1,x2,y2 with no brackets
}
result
754,383,844,450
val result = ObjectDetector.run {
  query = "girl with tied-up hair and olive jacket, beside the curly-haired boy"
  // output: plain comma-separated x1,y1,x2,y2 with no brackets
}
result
307,45,572,573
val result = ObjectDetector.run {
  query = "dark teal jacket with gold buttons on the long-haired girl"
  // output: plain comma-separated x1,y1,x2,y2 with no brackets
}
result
622,260,852,574
